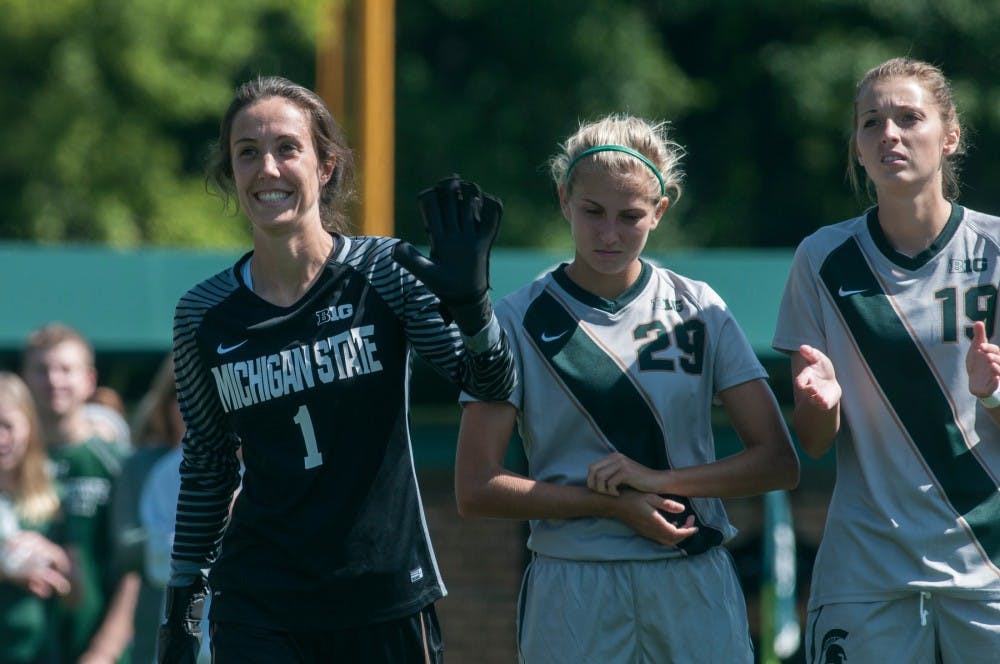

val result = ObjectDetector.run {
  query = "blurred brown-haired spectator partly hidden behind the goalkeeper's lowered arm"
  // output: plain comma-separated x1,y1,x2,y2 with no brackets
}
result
111,355,184,664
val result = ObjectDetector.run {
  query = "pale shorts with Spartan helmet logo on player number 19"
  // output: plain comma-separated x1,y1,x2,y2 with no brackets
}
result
806,592,1000,664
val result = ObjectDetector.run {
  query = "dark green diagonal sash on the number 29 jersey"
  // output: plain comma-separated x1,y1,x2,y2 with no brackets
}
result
524,292,722,554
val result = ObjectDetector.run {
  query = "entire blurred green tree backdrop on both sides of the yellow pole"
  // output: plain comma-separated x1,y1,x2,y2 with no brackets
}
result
0,0,1000,250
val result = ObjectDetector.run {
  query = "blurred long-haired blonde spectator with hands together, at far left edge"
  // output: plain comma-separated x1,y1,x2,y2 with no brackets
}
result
0,372,71,664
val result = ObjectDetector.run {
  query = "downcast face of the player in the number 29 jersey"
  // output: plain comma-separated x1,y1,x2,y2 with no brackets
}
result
559,166,668,299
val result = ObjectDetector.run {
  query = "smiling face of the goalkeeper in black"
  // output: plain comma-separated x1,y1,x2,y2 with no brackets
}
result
230,97,333,232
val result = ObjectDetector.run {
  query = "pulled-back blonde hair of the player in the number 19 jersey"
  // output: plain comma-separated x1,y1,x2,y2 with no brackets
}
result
847,58,966,201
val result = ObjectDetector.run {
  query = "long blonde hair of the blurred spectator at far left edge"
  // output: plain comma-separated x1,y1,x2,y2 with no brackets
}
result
0,371,59,523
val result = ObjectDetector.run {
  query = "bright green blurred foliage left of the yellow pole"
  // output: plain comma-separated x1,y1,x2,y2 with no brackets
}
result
0,0,315,246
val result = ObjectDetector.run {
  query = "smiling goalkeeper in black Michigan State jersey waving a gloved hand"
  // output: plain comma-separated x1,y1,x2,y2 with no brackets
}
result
159,77,513,663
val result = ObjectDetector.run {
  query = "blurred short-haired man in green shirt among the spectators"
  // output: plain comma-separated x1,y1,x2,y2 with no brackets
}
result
22,323,139,664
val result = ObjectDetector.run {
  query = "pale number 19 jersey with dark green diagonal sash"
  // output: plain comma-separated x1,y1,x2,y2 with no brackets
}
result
773,205,1000,609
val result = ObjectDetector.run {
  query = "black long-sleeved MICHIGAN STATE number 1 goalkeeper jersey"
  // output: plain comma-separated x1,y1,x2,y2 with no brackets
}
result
172,236,512,630
